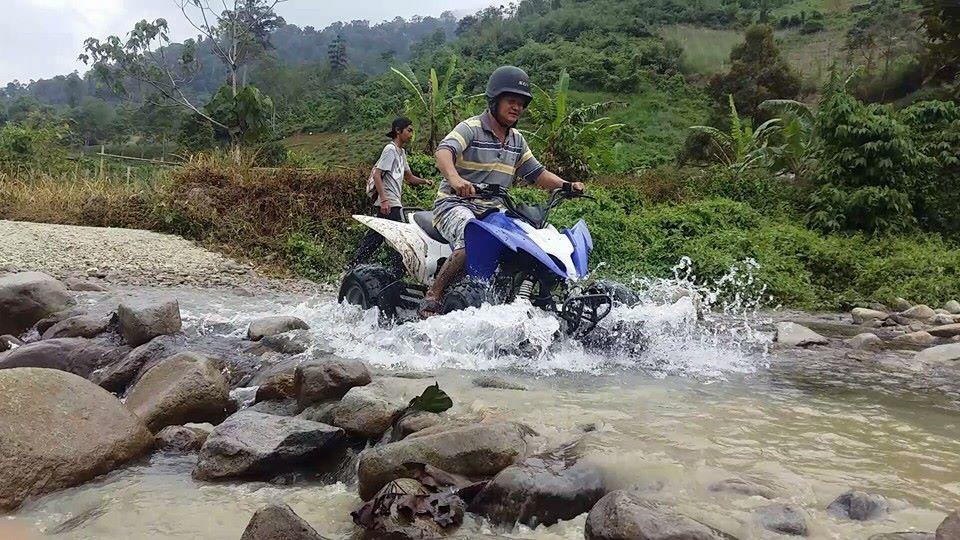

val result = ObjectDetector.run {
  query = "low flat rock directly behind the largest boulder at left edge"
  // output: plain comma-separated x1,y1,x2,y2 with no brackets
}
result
0,338,130,378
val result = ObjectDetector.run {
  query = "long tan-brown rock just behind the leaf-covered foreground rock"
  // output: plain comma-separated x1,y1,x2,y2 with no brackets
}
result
358,422,536,501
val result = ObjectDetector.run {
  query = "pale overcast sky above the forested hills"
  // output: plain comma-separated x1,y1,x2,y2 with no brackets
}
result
0,0,496,85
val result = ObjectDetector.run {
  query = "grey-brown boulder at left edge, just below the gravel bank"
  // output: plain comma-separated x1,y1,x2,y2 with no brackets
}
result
0,272,74,335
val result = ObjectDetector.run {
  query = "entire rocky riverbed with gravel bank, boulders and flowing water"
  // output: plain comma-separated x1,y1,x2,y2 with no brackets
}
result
0,222,960,540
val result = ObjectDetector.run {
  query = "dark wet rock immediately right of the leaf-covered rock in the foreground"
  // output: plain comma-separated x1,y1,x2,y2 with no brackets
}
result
470,445,607,528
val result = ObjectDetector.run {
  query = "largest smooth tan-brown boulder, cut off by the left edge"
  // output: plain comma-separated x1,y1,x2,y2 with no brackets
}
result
0,368,153,510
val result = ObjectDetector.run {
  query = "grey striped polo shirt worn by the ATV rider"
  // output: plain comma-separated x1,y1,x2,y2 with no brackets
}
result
433,112,545,215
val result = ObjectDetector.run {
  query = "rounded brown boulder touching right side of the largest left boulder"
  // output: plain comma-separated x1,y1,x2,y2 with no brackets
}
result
126,352,234,432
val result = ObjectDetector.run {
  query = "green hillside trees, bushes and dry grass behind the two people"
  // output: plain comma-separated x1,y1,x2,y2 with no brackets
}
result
0,0,960,309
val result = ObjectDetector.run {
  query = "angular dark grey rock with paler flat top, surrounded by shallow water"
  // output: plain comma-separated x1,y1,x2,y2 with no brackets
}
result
193,411,345,480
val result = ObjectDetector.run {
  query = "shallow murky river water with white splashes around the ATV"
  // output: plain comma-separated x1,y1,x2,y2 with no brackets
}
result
0,280,960,540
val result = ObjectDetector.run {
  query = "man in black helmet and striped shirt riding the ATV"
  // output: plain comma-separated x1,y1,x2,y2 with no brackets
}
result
419,66,584,318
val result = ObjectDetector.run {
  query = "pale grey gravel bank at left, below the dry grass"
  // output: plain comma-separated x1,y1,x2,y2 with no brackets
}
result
0,220,325,292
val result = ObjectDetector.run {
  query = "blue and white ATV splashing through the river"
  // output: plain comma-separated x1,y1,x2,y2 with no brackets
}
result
339,184,638,337
